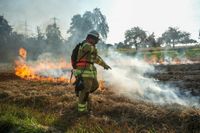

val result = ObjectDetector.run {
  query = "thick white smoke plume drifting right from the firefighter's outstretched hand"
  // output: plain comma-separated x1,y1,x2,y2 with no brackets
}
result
104,51,200,107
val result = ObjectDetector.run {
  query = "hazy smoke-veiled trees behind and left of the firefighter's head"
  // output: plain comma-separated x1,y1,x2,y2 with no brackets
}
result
0,8,109,62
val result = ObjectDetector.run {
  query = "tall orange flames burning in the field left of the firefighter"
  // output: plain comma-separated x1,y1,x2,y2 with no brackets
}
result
15,48,70,83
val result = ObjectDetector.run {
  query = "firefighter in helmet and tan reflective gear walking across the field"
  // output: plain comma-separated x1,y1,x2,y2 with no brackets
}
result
74,30,111,112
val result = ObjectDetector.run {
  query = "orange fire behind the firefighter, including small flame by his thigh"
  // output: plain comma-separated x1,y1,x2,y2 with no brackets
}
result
15,48,105,90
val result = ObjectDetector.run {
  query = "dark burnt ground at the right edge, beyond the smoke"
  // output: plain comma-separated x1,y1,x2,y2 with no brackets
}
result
151,63,200,96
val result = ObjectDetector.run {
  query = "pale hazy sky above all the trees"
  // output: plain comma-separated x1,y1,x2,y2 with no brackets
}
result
0,0,200,44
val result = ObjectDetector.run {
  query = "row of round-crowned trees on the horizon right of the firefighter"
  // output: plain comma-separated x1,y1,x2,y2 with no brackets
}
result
115,27,197,50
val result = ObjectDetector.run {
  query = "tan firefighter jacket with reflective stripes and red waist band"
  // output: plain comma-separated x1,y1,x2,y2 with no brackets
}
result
74,42,106,78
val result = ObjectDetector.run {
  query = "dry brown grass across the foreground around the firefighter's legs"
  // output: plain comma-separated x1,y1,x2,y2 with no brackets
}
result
0,65,200,133
